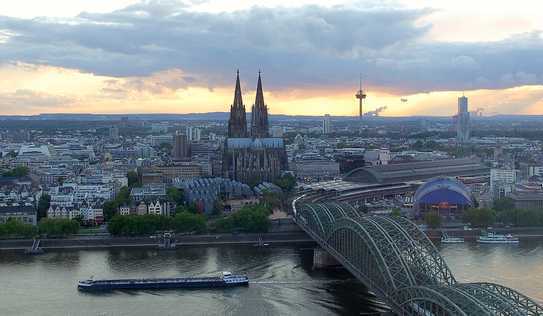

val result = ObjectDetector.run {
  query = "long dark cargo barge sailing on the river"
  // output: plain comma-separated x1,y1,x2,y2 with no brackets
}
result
77,272,249,291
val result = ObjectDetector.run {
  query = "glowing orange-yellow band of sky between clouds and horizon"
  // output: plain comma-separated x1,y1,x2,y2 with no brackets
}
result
0,64,543,116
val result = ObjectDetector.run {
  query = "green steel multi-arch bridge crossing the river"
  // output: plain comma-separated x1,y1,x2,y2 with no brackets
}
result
293,200,543,316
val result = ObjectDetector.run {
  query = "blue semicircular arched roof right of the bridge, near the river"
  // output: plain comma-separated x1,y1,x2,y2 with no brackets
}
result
414,177,473,205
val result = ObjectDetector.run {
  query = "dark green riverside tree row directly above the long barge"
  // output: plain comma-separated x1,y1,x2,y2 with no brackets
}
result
108,212,206,236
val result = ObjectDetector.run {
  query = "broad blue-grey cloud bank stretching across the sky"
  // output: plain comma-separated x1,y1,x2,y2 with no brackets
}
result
0,1,543,92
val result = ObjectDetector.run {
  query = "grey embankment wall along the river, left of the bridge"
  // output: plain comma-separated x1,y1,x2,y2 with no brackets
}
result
0,231,315,250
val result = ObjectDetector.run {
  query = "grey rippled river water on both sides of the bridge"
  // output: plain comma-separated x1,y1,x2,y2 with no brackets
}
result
0,243,543,316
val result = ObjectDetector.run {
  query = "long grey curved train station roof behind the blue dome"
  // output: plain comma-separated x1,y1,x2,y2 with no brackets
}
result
343,158,489,184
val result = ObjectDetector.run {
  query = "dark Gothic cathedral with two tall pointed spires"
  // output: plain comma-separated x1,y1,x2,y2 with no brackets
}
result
223,71,287,185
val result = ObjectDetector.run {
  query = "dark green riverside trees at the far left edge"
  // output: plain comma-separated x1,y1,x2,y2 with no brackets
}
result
0,218,79,238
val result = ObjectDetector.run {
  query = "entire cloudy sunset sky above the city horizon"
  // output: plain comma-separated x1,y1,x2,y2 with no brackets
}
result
0,0,543,116
